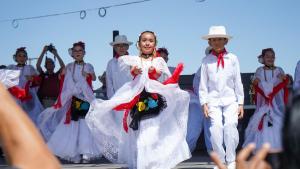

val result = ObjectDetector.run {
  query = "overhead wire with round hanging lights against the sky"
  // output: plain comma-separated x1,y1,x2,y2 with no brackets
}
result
0,0,152,28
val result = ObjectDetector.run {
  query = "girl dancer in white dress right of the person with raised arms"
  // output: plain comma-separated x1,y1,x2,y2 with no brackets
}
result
39,42,101,163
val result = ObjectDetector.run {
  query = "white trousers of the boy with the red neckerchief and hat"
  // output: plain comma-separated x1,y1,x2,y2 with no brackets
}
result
208,102,239,163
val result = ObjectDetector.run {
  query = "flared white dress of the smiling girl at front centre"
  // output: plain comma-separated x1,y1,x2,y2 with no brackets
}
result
86,56,191,169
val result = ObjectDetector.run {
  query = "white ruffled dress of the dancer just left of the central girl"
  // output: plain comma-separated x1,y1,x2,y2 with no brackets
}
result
38,63,101,163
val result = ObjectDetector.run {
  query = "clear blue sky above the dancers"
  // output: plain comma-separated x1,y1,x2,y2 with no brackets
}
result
0,0,300,86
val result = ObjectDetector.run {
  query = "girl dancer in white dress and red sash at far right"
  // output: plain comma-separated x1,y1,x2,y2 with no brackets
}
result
243,48,289,168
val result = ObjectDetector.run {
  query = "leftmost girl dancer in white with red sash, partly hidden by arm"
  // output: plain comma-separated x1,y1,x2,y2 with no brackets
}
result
7,47,44,124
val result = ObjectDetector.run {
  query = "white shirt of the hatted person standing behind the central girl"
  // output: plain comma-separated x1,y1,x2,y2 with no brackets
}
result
106,56,132,99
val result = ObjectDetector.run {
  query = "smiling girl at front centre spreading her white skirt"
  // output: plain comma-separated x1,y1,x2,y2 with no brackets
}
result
86,31,190,169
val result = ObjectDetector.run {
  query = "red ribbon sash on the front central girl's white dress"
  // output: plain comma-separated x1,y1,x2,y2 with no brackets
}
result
113,63,183,133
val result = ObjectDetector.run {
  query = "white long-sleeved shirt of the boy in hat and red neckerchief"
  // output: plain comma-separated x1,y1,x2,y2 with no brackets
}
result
199,53,244,106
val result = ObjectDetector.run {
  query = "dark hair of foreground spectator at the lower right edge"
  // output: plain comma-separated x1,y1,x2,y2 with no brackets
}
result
281,91,300,169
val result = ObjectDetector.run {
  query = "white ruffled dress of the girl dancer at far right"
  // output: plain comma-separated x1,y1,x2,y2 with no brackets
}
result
243,67,285,151
